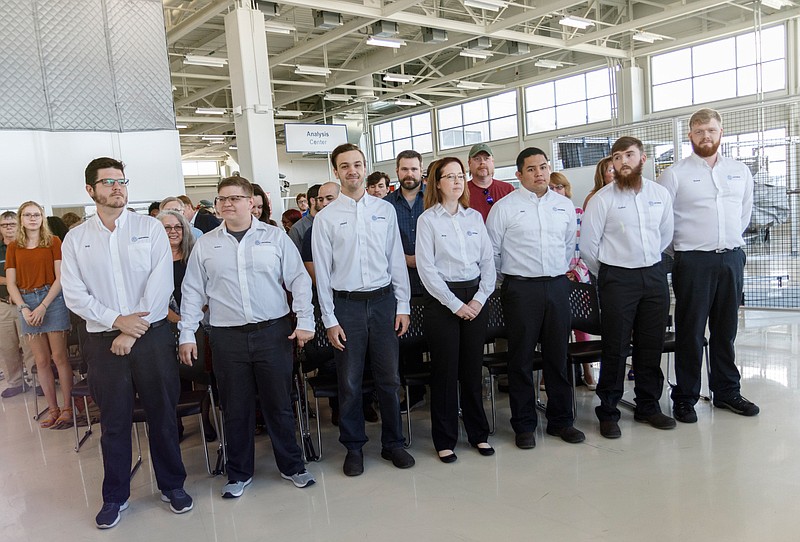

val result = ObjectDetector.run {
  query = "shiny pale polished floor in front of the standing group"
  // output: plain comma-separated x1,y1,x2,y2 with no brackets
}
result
0,311,800,542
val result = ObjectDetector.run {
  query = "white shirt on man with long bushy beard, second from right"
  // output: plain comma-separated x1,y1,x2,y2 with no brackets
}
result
581,179,674,275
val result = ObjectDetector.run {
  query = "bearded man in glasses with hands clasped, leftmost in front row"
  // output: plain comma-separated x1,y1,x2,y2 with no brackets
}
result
61,158,193,529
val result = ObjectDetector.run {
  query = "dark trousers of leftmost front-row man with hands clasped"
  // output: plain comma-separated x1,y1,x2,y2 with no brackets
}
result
84,325,186,503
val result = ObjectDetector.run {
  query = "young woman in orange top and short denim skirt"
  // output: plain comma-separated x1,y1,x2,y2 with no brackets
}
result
6,201,73,429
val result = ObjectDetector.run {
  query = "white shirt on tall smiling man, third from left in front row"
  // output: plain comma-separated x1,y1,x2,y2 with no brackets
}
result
311,194,411,328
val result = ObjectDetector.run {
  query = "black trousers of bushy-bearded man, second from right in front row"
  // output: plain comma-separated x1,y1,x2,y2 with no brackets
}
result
592,262,669,421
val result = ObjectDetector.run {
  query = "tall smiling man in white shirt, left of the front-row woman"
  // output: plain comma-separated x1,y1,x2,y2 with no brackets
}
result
311,144,414,476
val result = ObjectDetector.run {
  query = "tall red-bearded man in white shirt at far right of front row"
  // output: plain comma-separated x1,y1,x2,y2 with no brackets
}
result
660,109,759,423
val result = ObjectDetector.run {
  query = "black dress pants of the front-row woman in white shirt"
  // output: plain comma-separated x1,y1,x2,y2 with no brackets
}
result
423,286,489,451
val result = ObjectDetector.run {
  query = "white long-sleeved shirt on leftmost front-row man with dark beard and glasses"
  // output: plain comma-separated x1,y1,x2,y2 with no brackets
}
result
61,211,174,333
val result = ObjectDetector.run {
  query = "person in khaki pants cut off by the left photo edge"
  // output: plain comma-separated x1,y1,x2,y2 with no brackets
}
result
0,211,34,399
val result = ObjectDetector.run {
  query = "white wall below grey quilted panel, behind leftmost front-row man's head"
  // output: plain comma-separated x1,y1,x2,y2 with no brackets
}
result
0,130,183,214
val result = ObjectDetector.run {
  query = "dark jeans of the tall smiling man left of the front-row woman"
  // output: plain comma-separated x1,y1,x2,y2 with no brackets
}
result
333,292,404,450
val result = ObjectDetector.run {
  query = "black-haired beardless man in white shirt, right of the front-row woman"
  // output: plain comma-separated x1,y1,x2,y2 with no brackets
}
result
486,147,585,449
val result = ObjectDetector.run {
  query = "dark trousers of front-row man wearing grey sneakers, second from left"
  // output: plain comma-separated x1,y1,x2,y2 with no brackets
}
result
210,316,305,481
